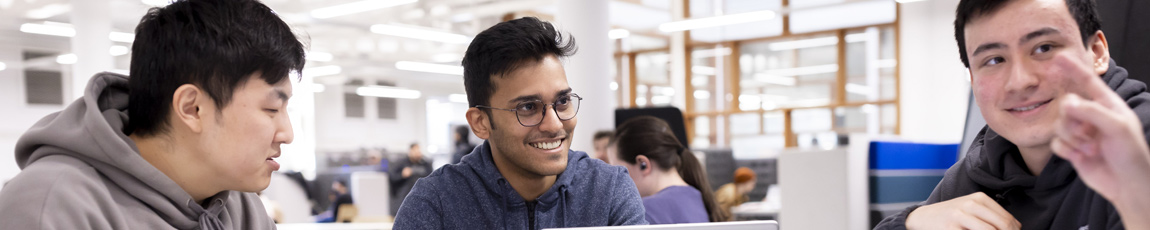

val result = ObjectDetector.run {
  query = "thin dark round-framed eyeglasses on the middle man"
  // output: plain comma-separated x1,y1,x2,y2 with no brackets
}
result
475,93,583,127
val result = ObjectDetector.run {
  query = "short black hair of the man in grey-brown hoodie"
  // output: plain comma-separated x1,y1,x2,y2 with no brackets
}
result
124,0,304,136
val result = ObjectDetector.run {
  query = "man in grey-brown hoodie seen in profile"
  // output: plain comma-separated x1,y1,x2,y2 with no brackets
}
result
0,0,304,230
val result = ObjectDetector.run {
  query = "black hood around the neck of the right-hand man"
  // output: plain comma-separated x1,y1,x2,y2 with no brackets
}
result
963,61,1148,193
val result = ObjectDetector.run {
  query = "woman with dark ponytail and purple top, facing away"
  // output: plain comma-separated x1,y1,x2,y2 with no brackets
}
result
607,116,728,224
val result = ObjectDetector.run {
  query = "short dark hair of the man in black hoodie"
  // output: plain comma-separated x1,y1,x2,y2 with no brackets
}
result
955,0,1102,68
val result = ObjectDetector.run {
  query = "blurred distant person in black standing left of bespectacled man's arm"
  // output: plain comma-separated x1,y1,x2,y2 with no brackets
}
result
388,143,431,215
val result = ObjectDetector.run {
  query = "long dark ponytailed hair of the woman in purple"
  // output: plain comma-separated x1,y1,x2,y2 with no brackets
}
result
611,116,728,222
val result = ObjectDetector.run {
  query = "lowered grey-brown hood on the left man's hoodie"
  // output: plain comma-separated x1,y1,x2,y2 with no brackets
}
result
16,72,233,229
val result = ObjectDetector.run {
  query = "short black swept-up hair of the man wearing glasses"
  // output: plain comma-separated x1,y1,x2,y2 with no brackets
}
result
463,17,577,108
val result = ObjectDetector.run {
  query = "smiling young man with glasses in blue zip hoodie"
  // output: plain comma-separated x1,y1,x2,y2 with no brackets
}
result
394,17,646,229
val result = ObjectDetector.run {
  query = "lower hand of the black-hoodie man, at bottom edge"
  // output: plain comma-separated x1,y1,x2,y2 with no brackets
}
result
906,192,1022,229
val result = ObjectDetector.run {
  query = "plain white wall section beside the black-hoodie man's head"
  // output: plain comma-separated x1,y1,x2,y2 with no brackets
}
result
898,0,971,143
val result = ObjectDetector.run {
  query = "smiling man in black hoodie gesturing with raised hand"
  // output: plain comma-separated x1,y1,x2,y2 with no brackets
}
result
876,0,1150,230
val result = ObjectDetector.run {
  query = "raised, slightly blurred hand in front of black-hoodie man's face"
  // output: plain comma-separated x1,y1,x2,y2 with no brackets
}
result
1050,74,1150,229
